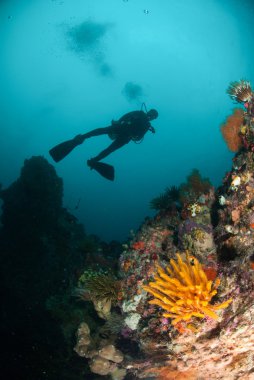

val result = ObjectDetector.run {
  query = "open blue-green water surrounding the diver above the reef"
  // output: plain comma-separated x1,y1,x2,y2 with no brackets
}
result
0,0,254,240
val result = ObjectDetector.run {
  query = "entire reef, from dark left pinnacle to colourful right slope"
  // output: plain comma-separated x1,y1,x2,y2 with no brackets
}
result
0,80,254,380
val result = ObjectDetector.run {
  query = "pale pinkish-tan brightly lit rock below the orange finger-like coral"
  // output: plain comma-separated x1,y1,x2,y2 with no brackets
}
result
140,305,254,380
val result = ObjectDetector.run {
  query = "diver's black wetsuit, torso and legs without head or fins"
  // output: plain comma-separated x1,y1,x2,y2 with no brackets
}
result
82,111,154,162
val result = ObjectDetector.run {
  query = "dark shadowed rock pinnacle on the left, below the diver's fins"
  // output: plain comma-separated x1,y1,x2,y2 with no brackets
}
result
0,157,96,380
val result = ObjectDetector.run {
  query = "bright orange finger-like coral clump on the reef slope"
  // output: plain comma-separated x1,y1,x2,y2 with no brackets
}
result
143,253,232,325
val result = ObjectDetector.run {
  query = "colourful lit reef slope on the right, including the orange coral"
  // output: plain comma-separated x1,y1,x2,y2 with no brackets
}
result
71,81,254,380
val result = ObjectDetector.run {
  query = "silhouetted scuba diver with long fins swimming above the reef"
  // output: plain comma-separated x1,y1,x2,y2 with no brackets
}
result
49,104,158,181
